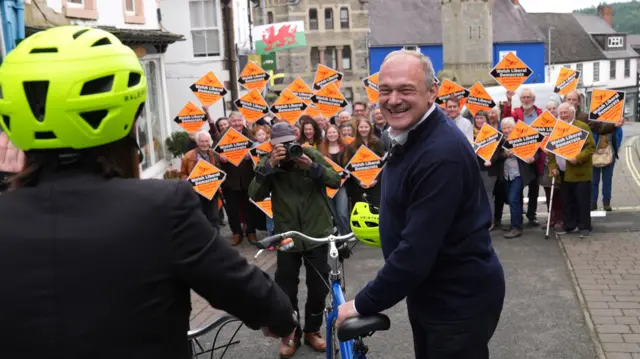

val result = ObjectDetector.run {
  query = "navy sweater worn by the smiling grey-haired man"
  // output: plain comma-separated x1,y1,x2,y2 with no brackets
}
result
355,108,505,320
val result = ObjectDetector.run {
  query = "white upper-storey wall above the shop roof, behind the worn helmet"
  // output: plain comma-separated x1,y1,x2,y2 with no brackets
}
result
47,0,160,30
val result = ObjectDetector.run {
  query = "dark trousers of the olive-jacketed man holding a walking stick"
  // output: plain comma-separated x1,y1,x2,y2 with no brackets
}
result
560,181,592,231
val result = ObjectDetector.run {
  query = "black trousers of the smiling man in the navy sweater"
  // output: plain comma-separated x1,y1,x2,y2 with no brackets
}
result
407,301,502,359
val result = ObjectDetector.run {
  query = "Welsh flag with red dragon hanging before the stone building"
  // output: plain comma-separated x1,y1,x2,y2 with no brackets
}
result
251,21,307,55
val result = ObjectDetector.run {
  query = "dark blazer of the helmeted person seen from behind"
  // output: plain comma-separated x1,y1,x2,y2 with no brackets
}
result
0,171,295,359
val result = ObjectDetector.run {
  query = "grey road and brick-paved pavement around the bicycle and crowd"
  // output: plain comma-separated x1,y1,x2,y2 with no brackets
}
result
191,123,640,359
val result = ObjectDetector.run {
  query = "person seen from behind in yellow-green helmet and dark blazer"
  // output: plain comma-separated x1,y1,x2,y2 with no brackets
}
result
0,26,297,359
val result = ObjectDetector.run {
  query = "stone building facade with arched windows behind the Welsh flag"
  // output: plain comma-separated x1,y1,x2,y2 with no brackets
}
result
254,0,369,104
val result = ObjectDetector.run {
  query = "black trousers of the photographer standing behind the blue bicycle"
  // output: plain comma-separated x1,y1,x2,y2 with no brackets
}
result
275,244,331,337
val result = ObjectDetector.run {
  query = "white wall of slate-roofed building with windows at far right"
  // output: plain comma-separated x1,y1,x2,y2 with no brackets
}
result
546,58,638,89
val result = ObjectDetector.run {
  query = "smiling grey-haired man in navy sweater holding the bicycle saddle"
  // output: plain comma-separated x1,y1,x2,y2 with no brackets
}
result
336,51,505,359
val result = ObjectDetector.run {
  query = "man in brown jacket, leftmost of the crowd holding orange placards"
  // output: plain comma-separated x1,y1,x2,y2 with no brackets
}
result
180,130,220,232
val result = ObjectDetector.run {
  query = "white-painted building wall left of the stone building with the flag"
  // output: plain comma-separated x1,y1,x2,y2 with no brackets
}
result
160,0,254,131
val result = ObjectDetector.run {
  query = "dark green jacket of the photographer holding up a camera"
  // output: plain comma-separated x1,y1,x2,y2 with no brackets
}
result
249,147,340,251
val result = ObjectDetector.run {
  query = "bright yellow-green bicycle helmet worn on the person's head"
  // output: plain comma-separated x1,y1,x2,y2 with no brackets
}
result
0,26,147,151
